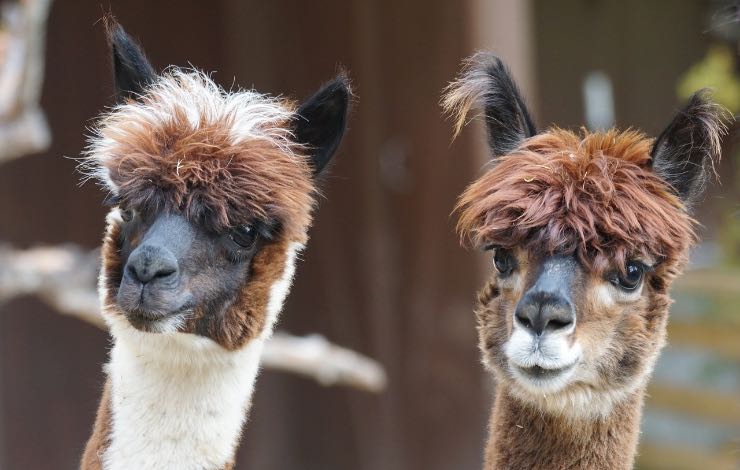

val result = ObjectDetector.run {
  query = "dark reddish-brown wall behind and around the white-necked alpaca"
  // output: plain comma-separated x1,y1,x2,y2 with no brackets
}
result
0,0,488,470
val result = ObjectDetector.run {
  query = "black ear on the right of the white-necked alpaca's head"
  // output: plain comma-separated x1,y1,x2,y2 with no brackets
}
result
293,73,352,176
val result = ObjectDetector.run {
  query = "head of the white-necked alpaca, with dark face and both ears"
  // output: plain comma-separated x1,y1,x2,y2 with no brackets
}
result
83,24,350,349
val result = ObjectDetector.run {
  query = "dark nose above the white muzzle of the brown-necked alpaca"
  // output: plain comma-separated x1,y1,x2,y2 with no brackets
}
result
514,292,576,336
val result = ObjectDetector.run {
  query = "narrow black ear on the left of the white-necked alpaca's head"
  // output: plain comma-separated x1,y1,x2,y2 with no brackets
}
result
106,19,157,102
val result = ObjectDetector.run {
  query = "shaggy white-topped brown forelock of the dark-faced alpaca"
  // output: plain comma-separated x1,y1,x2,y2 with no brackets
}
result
82,69,316,239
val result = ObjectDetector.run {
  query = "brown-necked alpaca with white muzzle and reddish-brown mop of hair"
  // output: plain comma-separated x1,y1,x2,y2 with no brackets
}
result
443,53,726,469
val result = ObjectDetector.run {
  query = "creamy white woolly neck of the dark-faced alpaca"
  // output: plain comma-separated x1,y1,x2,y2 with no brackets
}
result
102,334,264,470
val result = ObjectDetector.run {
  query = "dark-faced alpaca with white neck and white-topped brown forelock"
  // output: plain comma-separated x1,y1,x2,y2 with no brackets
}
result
82,25,350,470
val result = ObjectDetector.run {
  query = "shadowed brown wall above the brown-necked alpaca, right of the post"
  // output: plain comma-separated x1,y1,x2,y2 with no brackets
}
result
533,0,728,225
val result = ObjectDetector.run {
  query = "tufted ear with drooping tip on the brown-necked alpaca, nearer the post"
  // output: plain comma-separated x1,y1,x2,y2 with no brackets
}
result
442,52,537,157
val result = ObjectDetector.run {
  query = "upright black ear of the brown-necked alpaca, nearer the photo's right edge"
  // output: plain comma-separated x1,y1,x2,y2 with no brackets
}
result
651,90,729,208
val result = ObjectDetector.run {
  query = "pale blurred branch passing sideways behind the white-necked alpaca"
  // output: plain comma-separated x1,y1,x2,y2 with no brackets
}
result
0,245,386,392
